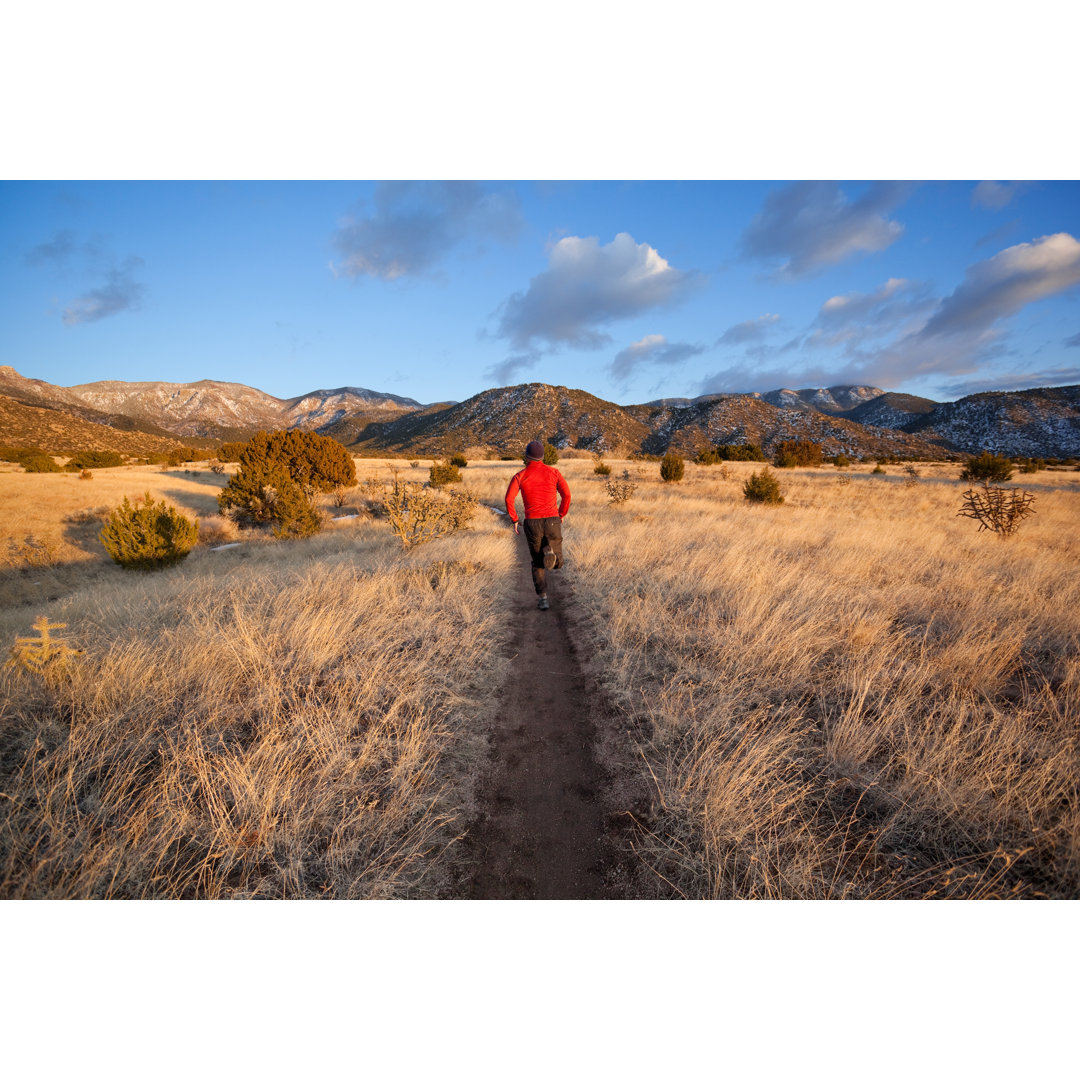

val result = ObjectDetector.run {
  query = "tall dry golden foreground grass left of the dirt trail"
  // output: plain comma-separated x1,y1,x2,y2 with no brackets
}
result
0,479,514,897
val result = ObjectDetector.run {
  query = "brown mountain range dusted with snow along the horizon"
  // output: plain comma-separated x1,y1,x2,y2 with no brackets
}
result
0,366,1080,458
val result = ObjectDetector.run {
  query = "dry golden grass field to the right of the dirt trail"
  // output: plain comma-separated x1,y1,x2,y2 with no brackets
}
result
566,463,1080,897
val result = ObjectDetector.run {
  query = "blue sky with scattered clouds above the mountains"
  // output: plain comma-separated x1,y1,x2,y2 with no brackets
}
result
0,180,1080,404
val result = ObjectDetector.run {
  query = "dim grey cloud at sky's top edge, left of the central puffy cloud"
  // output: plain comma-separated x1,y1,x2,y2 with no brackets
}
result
332,180,522,281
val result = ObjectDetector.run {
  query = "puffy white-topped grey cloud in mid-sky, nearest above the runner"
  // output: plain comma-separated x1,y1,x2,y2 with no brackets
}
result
496,232,694,353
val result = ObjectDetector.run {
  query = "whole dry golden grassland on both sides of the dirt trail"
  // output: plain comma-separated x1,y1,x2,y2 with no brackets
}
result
0,457,1080,899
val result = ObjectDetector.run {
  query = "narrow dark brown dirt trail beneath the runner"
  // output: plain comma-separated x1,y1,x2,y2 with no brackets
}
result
470,536,605,900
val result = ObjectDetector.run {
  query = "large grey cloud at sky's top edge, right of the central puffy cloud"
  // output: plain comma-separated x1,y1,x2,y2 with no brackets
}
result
742,180,913,276
